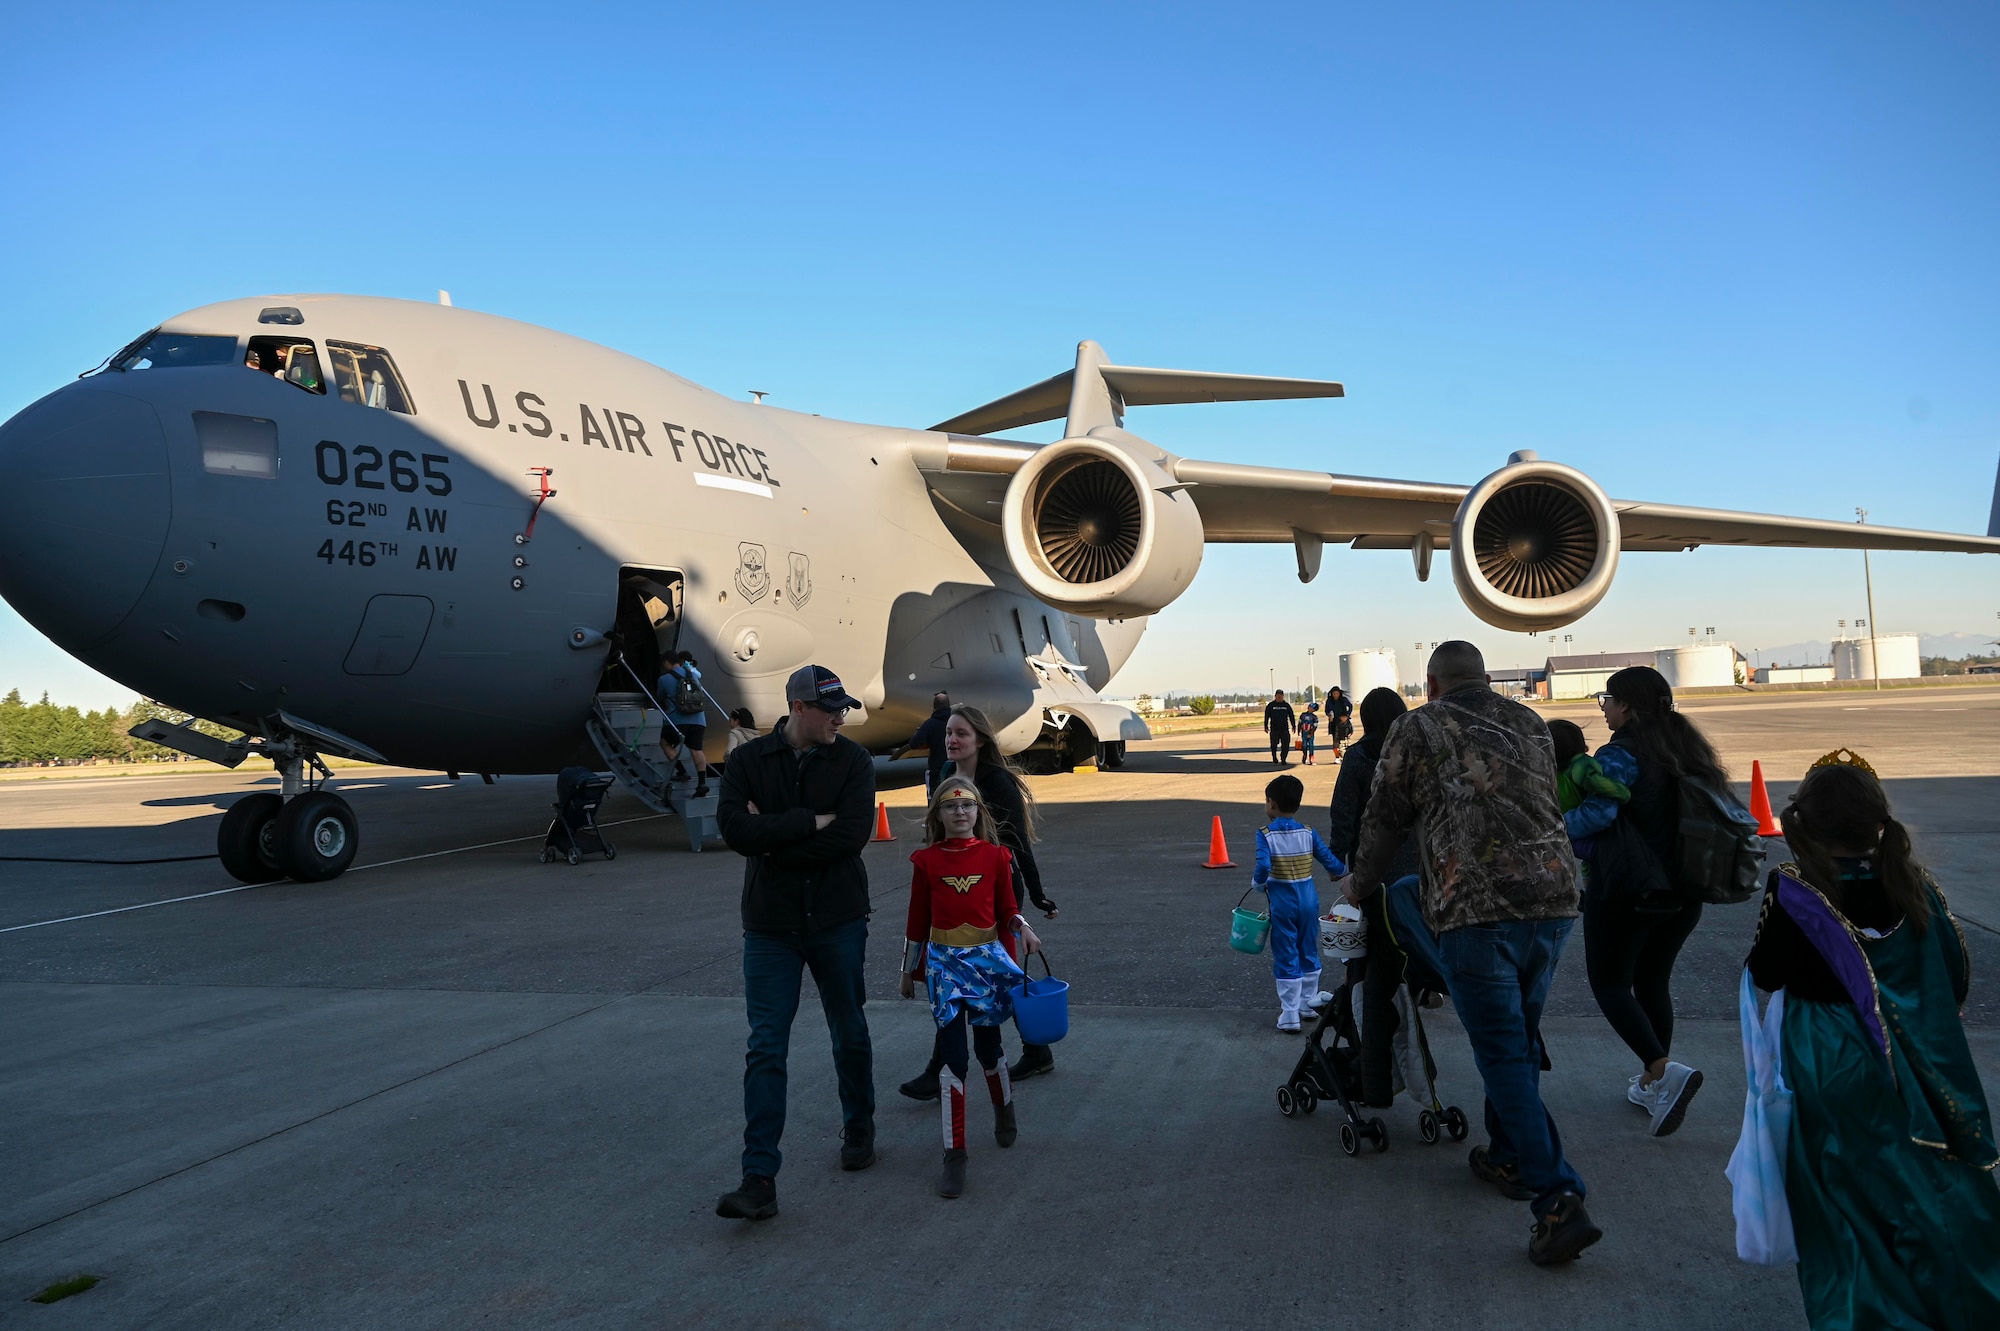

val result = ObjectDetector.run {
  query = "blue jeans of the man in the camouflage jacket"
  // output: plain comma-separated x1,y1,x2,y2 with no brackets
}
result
1438,919,1584,1219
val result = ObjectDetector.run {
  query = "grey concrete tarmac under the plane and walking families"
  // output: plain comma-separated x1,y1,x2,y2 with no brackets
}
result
0,689,2000,1327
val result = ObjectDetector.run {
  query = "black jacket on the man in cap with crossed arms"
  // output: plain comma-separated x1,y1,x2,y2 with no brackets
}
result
716,723,874,933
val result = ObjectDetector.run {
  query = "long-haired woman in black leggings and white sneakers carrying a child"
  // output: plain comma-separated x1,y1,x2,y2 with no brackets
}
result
1562,666,1728,1137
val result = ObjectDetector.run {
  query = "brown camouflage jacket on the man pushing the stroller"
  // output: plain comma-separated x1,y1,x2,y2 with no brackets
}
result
1354,685,1576,933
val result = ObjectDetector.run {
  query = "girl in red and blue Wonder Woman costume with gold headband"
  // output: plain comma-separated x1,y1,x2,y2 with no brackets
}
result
900,775,1042,1197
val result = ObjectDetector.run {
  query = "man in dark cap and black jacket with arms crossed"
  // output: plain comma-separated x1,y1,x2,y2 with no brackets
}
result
716,666,874,1219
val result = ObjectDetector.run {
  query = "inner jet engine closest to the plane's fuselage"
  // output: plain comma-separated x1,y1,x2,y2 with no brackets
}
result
1000,438,1204,620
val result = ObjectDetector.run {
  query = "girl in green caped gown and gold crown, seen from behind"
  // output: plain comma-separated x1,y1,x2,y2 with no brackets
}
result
1750,749,2000,1331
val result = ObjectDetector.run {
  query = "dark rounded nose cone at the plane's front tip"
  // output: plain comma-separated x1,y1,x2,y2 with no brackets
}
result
0,384,174,652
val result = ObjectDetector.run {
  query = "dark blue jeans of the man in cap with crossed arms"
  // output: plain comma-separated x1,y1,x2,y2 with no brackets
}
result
744,919,874,1177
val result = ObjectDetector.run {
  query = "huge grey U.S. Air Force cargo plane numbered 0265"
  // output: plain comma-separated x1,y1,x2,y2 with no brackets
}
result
0,296,2000,881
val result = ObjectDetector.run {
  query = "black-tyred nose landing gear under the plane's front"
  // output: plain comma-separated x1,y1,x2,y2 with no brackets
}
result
216,739,362,883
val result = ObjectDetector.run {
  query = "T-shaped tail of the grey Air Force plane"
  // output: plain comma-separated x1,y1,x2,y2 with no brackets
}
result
932,340,1346,436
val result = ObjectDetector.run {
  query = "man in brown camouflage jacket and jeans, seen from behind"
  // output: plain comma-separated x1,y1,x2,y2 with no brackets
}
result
1342,642,1604,1265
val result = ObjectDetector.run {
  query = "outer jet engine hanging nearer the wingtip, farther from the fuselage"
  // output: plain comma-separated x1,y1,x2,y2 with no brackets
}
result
1452,452,1618,634
